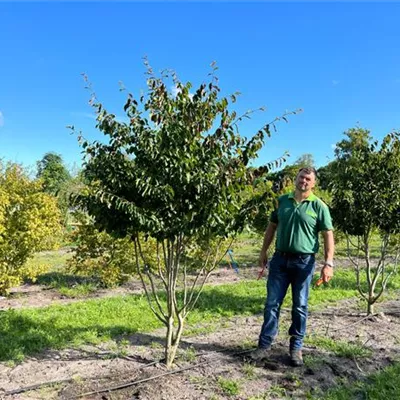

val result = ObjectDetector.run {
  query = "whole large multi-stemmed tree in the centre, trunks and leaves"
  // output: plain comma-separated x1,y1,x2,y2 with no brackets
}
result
72,63,296,367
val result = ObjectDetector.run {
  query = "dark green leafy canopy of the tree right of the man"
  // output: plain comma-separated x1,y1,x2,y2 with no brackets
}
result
331,128,400,235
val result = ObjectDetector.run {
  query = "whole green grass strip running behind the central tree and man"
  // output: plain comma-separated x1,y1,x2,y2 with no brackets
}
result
0,270,399,361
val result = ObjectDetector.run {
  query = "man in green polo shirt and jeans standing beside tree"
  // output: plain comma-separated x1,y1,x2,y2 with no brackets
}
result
251,168,334,367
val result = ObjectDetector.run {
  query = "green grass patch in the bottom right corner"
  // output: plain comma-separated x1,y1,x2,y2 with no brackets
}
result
312,363,400,400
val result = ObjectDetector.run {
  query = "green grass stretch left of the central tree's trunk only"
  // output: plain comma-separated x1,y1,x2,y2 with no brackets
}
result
0,296,160,361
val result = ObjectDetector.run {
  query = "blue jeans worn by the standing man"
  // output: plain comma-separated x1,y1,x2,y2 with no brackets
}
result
258,252,315,350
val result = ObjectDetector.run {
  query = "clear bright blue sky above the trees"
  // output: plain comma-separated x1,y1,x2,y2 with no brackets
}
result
0,0,400,172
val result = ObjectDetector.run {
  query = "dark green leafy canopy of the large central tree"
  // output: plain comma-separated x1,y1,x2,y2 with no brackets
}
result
76,64,294,240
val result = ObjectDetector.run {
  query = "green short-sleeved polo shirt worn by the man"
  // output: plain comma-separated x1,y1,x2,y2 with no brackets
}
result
270,193,333,253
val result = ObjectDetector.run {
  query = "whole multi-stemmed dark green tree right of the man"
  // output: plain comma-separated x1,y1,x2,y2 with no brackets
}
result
331,128,400,314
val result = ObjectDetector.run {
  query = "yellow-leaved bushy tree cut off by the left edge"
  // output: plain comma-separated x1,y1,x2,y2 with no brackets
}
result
0,163,61,294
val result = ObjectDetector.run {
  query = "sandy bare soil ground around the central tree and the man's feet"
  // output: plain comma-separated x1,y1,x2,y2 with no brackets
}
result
0,270,400,400
